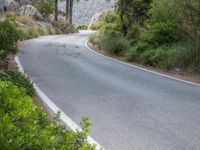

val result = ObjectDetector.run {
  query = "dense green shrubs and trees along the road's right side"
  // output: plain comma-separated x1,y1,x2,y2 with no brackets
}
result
88,0,200,83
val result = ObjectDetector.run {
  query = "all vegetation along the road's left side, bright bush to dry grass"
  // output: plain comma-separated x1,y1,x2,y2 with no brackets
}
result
0,1,95,150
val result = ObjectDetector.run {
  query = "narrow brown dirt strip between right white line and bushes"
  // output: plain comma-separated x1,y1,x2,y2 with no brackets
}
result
88,43,200,84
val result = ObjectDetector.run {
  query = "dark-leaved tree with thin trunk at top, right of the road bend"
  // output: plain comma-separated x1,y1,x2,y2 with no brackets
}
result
115,0,152,35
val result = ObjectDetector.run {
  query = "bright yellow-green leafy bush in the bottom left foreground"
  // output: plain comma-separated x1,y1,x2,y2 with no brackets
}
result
0,81,95,150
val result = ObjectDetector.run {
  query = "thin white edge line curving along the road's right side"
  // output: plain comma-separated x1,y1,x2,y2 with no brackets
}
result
85,40,200,87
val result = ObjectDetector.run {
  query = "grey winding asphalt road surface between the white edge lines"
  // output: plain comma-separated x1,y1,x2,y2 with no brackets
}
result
19,32,200,150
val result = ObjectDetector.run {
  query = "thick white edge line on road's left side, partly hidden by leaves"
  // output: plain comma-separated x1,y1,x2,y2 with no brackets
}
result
15,56,105,150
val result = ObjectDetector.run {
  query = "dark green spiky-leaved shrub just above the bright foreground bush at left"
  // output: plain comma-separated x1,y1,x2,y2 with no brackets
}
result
0,70,35,96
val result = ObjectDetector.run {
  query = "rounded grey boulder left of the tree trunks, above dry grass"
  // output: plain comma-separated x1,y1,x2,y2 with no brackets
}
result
19,5,42,20
